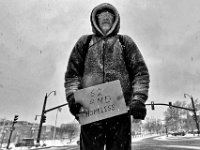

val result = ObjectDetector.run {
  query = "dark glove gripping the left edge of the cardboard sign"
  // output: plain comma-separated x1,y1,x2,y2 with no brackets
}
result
67,94,83,120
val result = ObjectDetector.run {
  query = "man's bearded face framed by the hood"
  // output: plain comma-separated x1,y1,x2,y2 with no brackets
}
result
97,11,114,33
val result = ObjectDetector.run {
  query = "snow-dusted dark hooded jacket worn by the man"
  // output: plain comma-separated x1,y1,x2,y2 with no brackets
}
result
65,3,149,105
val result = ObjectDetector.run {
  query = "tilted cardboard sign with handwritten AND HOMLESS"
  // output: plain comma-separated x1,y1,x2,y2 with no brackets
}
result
74,80,128,125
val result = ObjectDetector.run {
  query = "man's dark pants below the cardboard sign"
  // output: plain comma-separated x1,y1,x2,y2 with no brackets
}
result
80,114,131,150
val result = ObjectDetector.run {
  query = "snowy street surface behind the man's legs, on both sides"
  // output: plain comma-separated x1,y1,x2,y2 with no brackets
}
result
35,135,200,150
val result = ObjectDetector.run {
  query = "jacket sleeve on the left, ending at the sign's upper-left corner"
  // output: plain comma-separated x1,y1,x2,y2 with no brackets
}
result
64,35,87,102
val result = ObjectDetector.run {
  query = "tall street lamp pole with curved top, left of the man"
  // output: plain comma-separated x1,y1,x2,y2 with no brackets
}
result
37,91,56,144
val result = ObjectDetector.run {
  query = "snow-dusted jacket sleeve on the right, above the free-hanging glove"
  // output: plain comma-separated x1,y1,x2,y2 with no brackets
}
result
123,35,150,103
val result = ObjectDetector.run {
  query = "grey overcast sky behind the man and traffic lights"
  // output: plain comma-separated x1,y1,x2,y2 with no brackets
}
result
0,0,200,124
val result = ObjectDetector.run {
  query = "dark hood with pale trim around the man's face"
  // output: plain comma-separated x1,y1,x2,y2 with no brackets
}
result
90,3,120,36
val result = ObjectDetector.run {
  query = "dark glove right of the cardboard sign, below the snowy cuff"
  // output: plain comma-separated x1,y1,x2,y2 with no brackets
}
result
130,100,147,120
